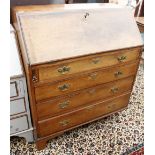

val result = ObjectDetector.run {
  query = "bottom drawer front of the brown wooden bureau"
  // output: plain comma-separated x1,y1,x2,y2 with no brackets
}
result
38,94,130,137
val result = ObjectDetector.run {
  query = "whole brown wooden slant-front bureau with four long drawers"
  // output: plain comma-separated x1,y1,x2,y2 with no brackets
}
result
13,4,142,149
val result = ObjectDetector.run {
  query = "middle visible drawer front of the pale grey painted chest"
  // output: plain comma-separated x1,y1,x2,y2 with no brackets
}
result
10,98,26,115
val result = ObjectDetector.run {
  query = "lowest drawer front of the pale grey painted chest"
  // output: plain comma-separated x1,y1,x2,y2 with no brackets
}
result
10,115,29,134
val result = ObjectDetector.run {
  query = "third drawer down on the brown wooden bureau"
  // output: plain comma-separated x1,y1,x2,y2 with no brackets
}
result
37,76,134,120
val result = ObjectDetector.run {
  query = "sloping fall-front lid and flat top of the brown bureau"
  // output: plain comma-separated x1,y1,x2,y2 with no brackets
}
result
14,4,142,65
